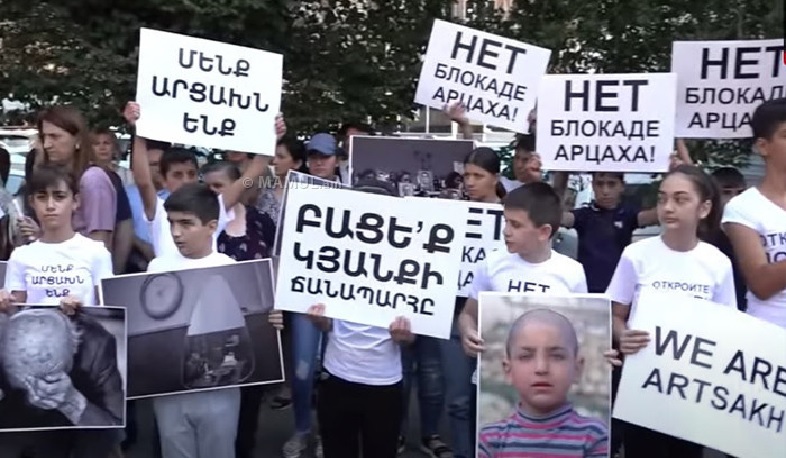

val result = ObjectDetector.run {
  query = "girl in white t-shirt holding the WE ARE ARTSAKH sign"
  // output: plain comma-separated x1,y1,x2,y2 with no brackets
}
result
606,165,737,458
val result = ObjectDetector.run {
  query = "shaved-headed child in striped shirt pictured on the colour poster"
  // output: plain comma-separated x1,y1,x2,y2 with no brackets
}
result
477,309,609,458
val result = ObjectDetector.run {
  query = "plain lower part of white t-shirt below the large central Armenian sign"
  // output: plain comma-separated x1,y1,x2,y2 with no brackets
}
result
324,319,402,386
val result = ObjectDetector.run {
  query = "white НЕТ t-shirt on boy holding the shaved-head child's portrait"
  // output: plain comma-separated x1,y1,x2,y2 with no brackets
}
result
467,250,587,385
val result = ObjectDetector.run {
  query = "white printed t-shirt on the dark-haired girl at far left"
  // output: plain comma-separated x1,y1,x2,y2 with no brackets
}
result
3,234,112,305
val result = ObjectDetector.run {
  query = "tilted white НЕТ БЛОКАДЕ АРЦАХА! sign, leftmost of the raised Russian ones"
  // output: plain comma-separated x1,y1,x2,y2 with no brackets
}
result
415,19,551,133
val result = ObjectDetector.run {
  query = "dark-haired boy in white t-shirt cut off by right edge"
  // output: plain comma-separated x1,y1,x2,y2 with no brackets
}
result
723,98,786,328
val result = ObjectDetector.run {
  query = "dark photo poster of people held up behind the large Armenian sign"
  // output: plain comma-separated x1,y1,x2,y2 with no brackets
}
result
349,136,475,199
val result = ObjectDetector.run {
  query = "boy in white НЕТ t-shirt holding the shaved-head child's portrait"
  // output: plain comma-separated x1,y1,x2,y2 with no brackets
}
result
459,182,587,449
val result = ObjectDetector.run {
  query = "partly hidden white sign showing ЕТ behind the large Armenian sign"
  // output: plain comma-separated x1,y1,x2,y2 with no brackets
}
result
410,197,507,297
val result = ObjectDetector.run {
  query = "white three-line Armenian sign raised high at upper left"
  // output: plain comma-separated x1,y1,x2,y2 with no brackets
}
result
136,28,283,156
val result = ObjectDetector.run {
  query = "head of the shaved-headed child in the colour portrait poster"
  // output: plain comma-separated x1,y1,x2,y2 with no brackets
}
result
503,321,583,414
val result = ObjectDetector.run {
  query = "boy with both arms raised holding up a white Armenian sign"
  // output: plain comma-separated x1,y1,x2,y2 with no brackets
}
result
124,102,286,257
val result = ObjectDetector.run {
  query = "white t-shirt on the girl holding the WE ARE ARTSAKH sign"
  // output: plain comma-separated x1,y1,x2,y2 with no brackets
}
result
606,237,737,316
